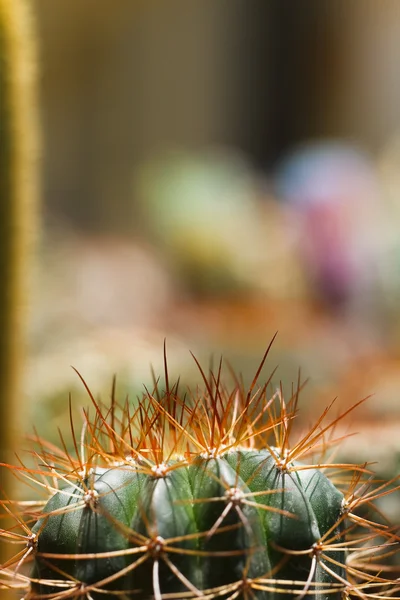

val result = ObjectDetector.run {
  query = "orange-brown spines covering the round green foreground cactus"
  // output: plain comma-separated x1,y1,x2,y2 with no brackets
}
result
0,342,400,600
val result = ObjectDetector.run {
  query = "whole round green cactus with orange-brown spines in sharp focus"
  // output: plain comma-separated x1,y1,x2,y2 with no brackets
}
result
1,344,396,600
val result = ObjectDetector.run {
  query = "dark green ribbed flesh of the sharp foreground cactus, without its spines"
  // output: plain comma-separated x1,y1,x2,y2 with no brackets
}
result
33,450,345,600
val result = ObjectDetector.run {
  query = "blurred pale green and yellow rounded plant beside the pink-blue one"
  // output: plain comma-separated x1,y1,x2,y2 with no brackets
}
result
136,152,265,296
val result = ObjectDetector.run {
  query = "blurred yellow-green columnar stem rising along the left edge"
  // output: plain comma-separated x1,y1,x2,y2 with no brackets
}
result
0,0,40,516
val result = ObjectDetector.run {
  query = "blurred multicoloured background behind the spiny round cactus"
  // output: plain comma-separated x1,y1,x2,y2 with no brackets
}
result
5,0,400,478
